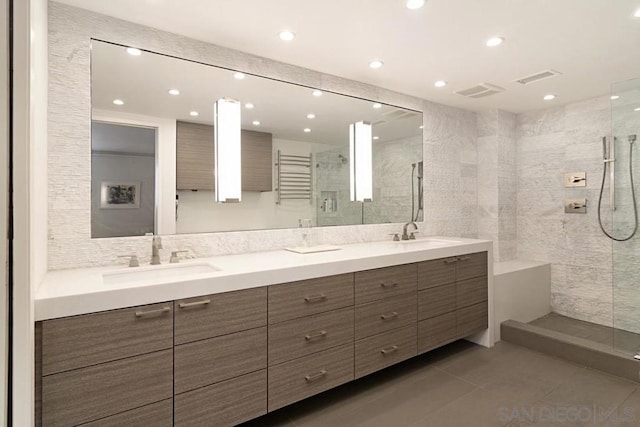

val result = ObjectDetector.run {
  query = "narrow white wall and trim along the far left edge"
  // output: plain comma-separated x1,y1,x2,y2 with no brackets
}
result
12,0,50,426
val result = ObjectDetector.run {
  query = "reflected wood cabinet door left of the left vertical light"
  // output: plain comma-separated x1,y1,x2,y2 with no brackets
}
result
176,122,214,190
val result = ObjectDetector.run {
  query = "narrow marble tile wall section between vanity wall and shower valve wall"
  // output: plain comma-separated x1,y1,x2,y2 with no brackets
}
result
478,110,517,261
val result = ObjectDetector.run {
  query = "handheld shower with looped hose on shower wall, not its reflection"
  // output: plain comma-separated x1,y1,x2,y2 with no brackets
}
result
598,135,638,242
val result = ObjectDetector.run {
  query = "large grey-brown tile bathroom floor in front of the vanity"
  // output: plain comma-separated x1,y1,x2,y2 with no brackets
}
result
244,341,640,427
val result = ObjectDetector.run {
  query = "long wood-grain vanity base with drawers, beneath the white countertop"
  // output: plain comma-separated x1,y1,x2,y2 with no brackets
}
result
35,251,488,427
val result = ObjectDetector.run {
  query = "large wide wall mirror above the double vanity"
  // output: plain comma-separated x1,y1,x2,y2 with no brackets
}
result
91,40,423,237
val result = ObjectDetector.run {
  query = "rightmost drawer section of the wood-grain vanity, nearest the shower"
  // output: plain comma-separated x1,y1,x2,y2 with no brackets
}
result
418,252,488,353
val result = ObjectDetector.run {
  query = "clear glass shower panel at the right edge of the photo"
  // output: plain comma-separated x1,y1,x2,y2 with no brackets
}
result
611,78,640,356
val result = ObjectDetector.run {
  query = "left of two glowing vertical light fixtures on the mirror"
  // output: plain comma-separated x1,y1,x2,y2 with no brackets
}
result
213,98,242,203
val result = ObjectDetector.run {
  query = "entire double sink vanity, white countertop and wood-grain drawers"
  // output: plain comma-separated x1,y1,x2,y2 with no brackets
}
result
36,238,491,426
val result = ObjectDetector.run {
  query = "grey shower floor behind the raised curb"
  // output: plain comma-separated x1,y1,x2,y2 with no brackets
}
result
529,313,640,356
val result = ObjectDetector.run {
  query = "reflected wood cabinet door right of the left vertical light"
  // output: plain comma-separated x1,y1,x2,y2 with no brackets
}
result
242,130,273,191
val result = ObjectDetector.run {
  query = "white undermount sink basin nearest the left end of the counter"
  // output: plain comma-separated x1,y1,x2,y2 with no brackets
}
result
102,262,220,285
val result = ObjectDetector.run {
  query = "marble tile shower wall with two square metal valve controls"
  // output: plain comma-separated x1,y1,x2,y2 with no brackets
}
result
516,97,613,325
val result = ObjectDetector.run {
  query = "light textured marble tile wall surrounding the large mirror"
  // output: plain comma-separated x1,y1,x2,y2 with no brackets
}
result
48,2,477,270
